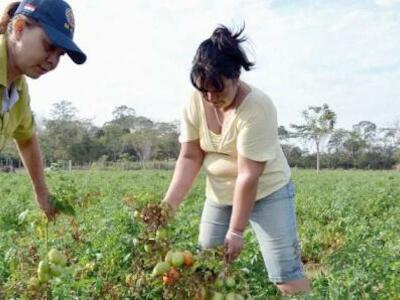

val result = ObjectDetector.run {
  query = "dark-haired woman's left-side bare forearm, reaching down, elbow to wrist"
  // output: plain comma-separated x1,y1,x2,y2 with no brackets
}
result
163,156,203,208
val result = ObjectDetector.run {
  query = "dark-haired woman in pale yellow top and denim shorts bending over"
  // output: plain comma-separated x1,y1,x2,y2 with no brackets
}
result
163,26,310,294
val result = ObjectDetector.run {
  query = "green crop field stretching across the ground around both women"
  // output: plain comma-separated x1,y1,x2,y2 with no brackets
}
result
0,170,400,299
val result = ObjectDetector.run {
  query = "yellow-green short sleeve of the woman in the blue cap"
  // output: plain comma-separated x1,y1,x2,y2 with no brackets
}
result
12,80,36,140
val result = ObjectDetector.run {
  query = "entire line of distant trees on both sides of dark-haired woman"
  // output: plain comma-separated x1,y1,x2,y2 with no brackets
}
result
0,101,400,170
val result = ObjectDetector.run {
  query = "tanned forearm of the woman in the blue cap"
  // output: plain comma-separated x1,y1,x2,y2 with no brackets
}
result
16,135,48,200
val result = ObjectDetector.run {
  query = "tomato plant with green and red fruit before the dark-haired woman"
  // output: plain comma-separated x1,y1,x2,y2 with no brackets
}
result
125,203,251,300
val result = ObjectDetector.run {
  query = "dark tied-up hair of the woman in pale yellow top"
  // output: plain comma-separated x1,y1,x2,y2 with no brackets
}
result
190,25,254,91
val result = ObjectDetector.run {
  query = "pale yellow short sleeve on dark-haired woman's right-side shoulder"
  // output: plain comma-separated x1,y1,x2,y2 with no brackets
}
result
236,98,280,162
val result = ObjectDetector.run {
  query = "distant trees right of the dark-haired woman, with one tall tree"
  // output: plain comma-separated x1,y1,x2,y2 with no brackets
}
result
278,104,400,171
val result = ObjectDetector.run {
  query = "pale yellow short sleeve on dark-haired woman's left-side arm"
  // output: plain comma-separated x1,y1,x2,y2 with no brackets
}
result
179,94,200,143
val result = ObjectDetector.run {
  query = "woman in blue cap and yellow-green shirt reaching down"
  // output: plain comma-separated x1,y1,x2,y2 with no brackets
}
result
0,0,86,219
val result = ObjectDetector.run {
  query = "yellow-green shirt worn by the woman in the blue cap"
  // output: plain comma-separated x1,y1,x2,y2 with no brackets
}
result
0,34,35,150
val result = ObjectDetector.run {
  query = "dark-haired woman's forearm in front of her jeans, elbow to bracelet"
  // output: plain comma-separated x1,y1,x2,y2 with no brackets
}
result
229,174,258,234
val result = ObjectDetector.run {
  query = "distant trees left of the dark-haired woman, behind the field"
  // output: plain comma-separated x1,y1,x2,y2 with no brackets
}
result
0,101,179,166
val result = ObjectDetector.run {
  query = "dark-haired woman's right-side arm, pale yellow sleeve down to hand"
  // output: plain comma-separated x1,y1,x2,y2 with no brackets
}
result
226,96,280,260
